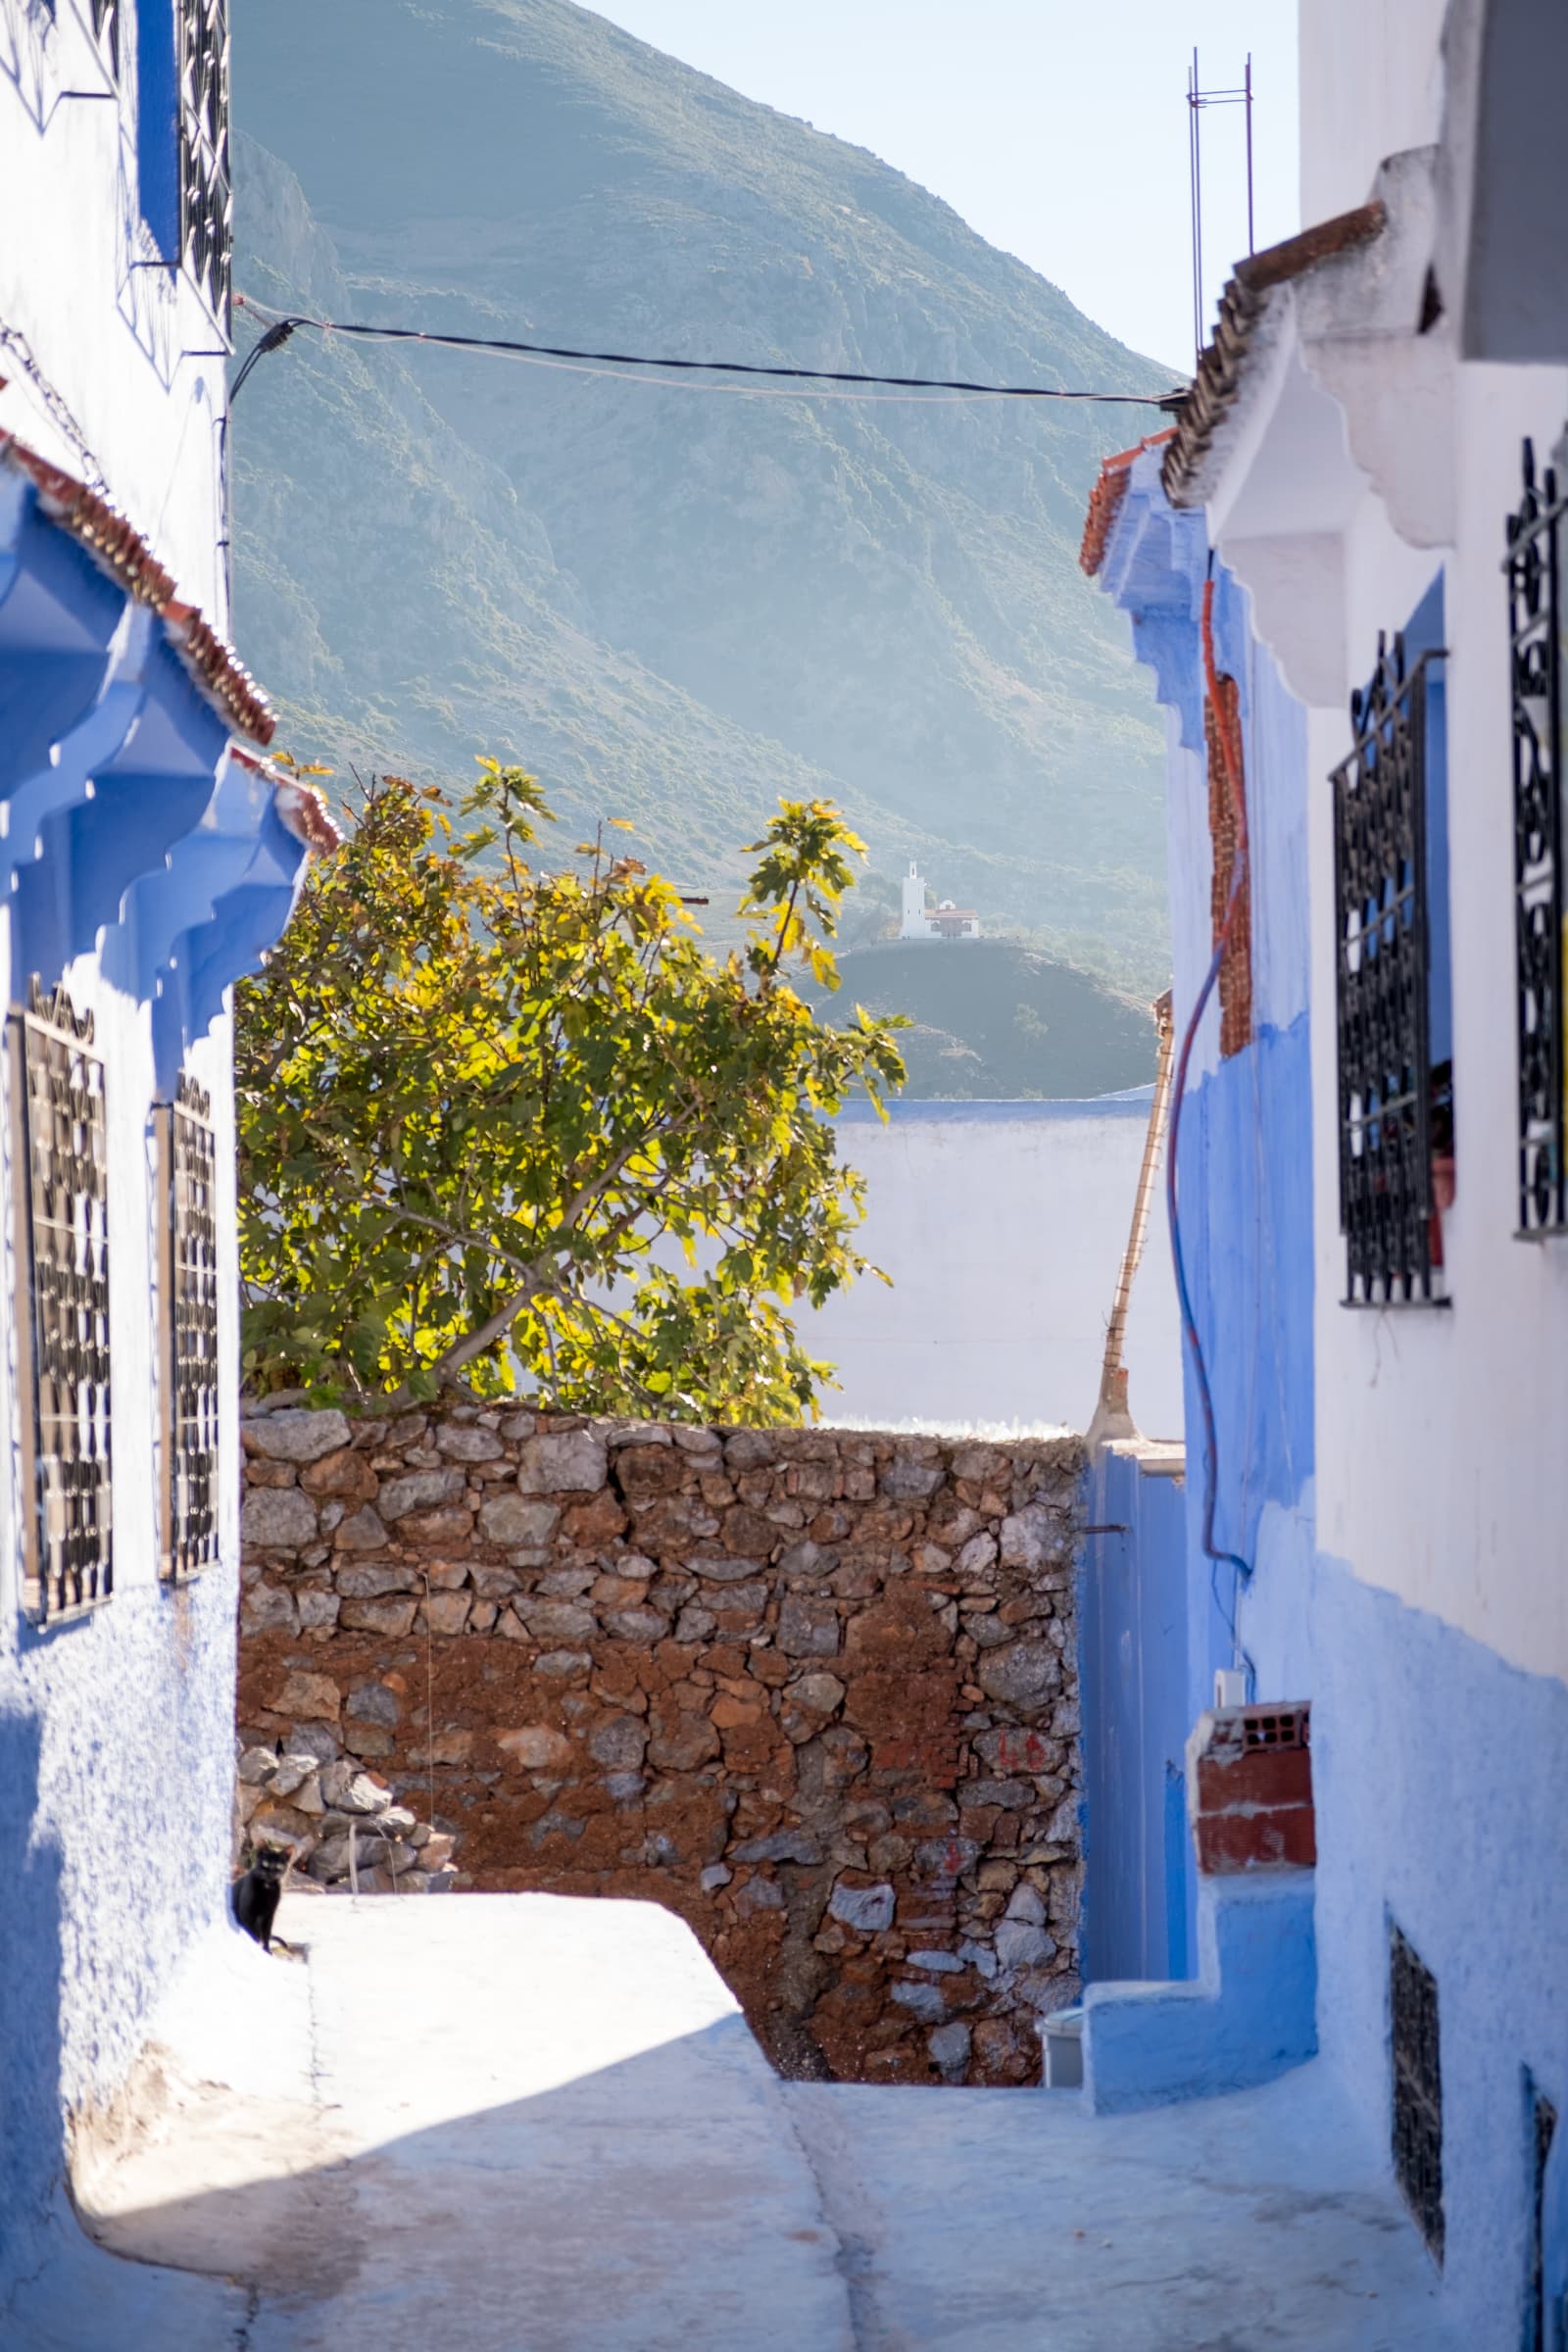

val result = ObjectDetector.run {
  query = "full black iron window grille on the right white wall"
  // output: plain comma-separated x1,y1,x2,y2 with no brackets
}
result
1333,635,1452,1307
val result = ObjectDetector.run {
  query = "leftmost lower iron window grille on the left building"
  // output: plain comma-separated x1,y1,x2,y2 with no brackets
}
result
10,978,116,1625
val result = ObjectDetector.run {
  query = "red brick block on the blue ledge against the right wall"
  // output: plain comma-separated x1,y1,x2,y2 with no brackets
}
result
1187,1705,1316,1877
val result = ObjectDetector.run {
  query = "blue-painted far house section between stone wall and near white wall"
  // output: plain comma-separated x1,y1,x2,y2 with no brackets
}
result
1081,437,1314,1981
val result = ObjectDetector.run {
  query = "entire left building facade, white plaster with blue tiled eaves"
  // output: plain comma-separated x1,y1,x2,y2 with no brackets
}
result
0,0,319,2305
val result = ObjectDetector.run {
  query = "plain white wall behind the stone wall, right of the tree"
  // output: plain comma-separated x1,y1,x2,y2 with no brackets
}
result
817,1087,1183,1437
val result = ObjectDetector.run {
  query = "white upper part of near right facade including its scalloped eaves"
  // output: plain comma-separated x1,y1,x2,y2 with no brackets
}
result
1203,0,1568,1677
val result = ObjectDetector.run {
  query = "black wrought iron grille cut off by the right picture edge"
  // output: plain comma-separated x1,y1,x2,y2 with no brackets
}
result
1504,442,1568,1242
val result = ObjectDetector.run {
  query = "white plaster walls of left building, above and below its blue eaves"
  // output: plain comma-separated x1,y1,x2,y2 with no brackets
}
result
0,0,250,2267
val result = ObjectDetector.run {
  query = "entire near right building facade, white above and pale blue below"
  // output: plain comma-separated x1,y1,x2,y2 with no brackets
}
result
1178,0,1568,2352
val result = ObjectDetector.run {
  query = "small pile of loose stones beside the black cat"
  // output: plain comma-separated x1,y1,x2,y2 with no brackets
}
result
235,1747,459,1895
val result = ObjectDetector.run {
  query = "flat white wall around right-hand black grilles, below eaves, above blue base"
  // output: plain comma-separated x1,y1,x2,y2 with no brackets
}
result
1309,365,1568,1677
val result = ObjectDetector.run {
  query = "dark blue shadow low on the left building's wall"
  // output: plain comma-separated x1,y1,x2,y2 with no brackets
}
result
0,1712,66,2295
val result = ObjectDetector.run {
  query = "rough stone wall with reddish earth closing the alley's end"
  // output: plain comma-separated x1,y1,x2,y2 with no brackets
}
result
240,1406,1084,2082
